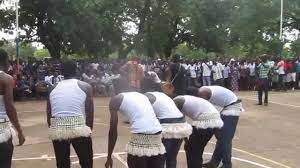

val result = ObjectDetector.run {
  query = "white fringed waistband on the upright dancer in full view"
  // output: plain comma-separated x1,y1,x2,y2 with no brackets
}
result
49,116,92,140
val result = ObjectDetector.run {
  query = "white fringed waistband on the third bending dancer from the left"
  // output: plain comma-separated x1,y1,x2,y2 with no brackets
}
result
192,113,224,129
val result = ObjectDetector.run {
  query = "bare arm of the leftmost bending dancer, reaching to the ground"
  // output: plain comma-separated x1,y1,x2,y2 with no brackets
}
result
105,94,123,168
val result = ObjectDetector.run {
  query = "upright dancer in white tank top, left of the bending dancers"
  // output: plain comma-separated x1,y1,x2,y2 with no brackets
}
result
47,62,94,168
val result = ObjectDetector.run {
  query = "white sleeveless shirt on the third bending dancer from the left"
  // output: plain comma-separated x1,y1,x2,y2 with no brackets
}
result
175,95,219,120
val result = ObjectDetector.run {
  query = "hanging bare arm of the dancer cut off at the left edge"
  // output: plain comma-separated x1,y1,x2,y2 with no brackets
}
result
4,77,25,145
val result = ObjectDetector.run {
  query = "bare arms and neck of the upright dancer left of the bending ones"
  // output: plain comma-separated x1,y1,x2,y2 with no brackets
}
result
47,78,94,130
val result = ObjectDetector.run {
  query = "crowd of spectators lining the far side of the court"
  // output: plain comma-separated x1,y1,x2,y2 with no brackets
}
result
9,54,300,98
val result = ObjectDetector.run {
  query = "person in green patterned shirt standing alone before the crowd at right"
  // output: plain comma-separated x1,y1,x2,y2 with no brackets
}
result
257,55,272,106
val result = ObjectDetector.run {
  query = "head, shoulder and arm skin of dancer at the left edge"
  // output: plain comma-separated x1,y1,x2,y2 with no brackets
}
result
0,63,25,146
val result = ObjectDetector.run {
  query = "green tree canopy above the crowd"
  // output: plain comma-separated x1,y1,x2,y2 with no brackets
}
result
0,0,300,58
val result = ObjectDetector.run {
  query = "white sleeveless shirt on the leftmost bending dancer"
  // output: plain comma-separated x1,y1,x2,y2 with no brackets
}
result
119,92,162,134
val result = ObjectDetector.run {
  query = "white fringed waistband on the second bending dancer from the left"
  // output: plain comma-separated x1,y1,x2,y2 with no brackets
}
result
161,122,193,139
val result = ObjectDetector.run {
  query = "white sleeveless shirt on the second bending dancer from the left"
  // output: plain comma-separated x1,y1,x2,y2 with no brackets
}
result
148,92,183,119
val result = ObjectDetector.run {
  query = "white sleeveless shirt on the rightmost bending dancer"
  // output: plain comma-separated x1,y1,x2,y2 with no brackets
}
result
203,86,238,107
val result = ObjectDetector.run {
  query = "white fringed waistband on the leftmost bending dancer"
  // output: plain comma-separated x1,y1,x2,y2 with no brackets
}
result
126,134,166,157
